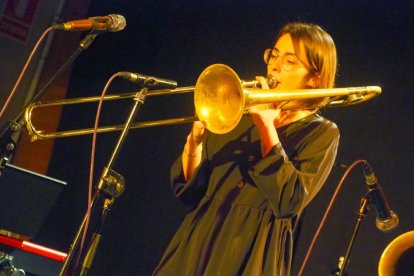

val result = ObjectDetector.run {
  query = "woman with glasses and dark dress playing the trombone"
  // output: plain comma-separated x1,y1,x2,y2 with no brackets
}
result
154,22,339,276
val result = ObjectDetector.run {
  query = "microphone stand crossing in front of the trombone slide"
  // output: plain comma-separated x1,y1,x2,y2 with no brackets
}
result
59,85,148,275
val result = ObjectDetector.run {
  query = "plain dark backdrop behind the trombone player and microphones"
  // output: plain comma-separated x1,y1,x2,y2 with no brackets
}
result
29,0,414,275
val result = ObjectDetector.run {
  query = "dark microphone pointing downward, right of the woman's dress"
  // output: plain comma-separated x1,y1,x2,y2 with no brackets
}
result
362,161,399,232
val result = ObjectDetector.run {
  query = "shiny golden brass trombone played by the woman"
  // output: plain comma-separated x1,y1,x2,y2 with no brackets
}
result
25,64,381,141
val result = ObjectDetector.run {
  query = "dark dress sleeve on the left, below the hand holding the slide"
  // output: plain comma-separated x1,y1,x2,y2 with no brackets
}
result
170,149,210,205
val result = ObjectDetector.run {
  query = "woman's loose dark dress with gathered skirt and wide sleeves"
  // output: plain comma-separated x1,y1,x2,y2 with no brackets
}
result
154,114,339,276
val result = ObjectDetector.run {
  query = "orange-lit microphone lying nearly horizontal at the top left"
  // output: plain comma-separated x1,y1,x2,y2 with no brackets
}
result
52,14,126,32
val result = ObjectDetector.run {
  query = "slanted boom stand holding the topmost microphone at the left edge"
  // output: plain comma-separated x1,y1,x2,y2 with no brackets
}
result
0,31,98,176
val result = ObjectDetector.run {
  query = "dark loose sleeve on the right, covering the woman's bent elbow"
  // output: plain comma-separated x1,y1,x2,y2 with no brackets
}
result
249,123,339,218
